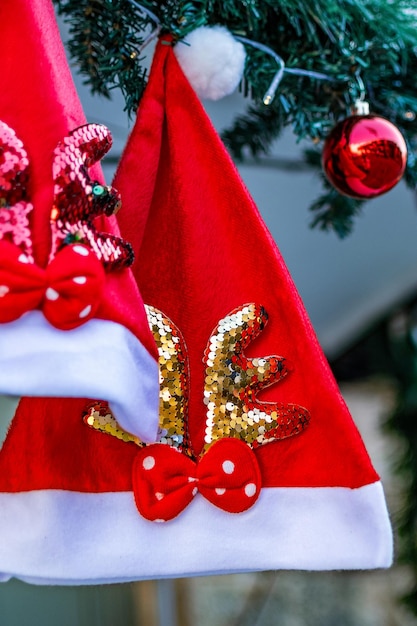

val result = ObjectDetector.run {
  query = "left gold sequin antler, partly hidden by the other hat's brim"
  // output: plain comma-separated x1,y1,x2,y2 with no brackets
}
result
83,306,191,456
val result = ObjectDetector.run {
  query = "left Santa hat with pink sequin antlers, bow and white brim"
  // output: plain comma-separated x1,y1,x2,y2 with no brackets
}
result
0,0,158,441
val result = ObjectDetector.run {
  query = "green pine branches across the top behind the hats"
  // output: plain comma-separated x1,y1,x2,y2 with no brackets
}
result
54,0,417,236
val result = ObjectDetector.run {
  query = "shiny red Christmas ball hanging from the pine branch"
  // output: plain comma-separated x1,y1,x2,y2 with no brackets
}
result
322,115,407,199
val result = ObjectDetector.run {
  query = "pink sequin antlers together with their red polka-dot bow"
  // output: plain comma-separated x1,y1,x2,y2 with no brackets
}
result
0,121,118,330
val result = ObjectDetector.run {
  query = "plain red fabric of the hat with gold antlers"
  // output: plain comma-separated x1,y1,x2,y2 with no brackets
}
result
0,35,378,492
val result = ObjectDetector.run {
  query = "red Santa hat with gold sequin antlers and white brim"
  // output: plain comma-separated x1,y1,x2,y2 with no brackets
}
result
0,33,392,584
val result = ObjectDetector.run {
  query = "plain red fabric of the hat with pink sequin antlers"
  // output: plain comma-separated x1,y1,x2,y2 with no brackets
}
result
0,0,156,356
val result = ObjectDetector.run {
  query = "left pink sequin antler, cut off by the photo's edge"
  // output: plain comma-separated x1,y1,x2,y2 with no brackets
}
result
0,121,33,262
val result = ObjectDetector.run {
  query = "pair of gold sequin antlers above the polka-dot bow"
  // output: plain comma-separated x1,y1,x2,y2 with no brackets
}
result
84,304,310,456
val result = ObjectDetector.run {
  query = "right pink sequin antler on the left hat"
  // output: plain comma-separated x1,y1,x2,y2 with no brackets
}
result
51,124,134,271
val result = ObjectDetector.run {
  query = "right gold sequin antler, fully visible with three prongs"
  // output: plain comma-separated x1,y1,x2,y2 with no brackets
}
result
204,304,310,448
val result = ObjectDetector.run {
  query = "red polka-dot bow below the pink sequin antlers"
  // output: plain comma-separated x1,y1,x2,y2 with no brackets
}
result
0,240,105,330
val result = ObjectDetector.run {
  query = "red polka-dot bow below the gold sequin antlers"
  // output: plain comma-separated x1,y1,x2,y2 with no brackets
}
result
133,438,261,522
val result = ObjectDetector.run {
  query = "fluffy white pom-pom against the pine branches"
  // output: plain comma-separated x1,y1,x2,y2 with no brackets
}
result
174,26,246,100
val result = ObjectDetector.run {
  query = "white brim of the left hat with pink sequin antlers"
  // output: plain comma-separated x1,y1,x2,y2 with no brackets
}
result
0,311,159,441
